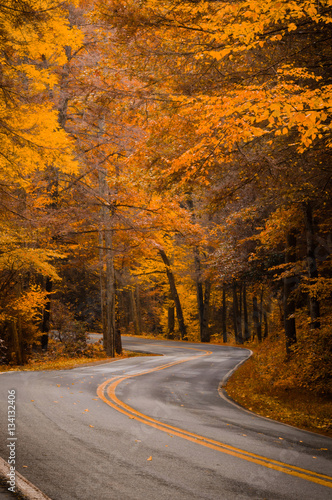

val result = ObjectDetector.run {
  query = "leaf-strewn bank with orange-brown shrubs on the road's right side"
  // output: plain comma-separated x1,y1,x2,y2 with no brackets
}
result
225,335,332,437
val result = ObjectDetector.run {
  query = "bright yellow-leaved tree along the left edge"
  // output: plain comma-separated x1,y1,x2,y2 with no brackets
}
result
0,0,80,363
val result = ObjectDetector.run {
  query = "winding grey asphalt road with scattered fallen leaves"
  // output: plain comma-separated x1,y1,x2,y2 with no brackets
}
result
0,337,332,500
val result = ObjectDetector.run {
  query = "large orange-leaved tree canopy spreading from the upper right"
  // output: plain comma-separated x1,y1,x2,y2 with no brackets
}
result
93,0,332,352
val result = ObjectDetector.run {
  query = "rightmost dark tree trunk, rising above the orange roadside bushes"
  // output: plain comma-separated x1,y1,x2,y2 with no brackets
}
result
304,202,320,329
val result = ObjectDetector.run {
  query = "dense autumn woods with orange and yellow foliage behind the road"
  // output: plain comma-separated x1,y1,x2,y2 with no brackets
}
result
0,0,332,392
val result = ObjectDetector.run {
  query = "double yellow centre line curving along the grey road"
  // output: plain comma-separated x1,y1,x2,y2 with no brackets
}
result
97,347,332,488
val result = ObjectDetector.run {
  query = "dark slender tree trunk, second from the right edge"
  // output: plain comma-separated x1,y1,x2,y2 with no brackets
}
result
284,232,296,354
